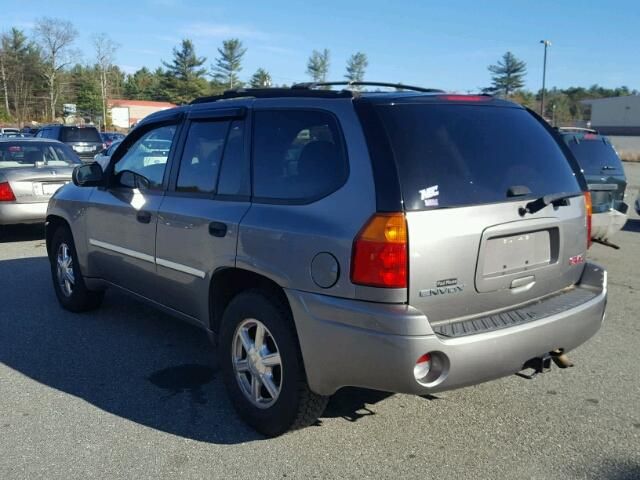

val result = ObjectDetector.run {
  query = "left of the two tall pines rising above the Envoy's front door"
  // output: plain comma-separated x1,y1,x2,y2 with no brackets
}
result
162,39,207,104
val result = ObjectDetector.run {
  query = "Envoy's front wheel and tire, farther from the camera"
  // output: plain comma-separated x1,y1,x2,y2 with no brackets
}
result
49,226,104,312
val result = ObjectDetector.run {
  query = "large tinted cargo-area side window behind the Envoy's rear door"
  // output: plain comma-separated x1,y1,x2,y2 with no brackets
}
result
253,110,348,202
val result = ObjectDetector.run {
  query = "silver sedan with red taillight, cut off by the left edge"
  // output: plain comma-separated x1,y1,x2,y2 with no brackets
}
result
0,138,81,225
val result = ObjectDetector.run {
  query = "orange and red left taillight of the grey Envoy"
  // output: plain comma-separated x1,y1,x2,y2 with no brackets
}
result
351,213,407,288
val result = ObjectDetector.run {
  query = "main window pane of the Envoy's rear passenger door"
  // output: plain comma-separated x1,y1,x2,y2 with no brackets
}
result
176,121,229,193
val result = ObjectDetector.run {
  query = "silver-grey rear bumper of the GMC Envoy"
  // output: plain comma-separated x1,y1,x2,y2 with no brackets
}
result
286,264,607,395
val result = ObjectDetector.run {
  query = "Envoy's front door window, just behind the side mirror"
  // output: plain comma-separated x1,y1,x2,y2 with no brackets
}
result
113,125,177,189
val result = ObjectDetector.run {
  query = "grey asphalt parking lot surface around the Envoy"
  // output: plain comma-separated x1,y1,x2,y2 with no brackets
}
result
0,163,640,479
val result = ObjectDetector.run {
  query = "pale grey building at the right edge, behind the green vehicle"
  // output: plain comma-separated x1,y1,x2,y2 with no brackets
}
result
581,95,640,136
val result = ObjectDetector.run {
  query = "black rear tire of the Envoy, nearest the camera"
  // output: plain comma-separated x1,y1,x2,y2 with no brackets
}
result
218,290,329,437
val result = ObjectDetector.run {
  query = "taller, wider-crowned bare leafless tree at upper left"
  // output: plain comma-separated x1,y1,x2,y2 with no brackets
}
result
34,17,78,121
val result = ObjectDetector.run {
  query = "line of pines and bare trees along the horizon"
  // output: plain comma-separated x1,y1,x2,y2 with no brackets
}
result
0,17,637,125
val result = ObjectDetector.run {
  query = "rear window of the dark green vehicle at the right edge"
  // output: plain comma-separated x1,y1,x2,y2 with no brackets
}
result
565,136,623,175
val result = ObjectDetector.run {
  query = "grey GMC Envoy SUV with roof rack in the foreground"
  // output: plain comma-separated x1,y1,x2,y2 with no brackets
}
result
46,85,606,436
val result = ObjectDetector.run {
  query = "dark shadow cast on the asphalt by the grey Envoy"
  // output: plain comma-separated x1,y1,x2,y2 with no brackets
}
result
0,257,390,444
